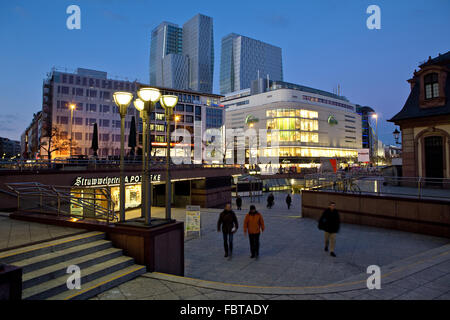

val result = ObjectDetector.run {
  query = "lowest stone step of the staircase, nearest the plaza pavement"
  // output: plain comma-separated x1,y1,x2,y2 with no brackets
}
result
48,265,147,300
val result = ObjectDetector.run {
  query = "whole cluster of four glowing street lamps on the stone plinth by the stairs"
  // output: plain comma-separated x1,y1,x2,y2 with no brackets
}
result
113,88,178,225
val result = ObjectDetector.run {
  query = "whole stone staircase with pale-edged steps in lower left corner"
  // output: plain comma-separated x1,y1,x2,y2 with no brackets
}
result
0,232,146,300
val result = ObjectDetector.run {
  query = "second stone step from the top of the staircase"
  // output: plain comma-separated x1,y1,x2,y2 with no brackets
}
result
13,240,112,274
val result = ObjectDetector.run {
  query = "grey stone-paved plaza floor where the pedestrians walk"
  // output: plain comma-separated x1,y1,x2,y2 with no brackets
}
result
94,193,450,300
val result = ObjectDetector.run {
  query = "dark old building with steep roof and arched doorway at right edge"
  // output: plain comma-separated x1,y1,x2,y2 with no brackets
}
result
389,51,450,178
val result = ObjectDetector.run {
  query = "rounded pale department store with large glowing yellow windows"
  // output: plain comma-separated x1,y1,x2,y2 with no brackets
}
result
222,79,362,168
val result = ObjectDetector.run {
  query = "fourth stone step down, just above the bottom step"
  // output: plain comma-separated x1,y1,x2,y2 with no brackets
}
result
22,256,134,300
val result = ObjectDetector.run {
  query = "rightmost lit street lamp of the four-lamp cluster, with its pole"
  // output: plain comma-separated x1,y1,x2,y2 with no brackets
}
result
160,95,178,219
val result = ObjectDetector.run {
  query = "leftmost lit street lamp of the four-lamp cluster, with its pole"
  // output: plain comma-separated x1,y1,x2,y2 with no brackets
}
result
113,91,133,222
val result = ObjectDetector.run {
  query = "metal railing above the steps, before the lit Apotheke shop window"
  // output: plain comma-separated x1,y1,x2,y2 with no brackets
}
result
6,182,118,223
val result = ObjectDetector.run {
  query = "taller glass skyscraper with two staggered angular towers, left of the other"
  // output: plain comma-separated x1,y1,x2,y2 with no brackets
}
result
150,14,214,93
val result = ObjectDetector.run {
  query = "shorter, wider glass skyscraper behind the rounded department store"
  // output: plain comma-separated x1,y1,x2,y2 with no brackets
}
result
220,33,283,94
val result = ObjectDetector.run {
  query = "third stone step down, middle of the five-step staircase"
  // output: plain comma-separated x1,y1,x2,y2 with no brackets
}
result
22,248,122,289
